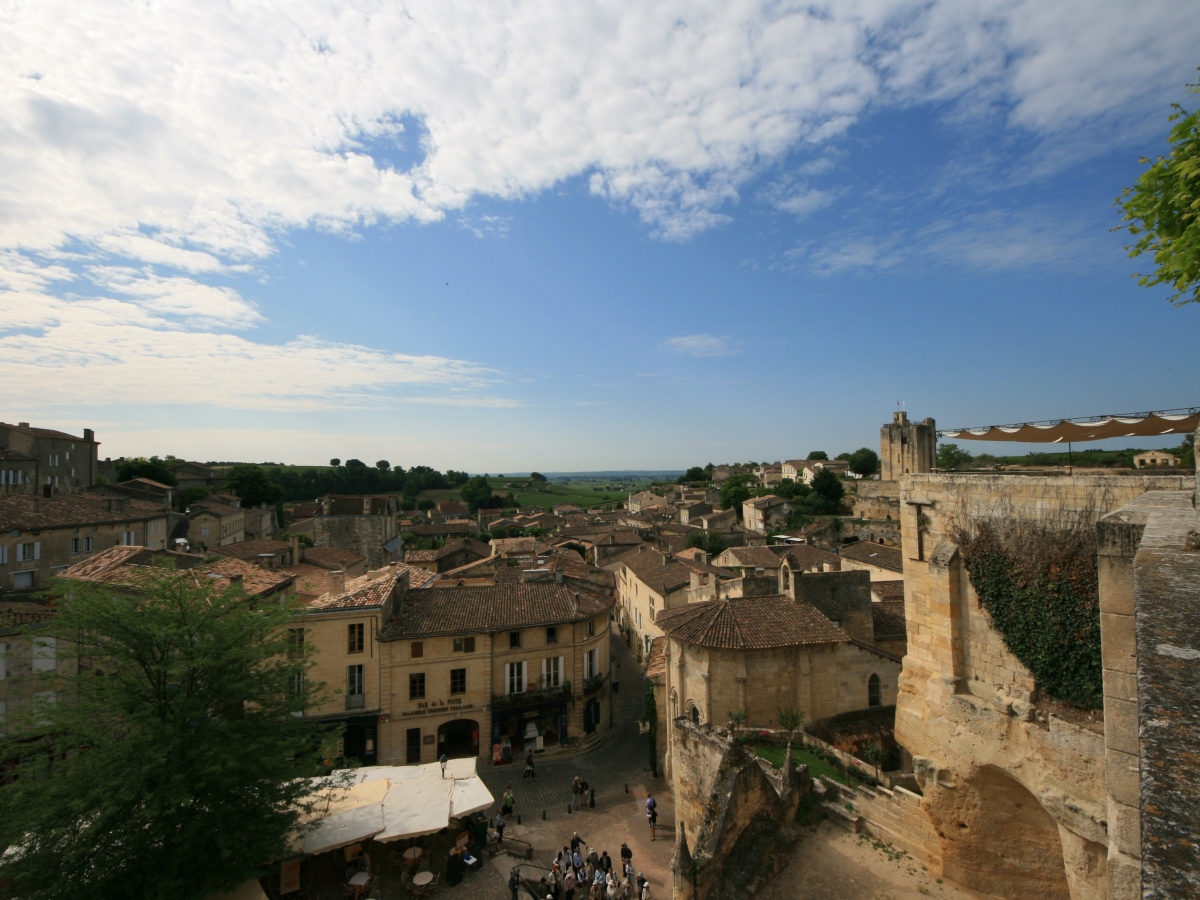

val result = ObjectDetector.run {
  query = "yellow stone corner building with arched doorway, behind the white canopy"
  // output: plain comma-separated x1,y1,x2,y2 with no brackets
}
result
379,572,613,764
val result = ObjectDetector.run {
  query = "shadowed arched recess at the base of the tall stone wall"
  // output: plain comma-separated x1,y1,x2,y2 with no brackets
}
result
929,766,1070,900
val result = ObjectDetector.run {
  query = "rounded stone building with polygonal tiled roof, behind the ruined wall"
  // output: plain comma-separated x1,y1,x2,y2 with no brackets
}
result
656,592,900,776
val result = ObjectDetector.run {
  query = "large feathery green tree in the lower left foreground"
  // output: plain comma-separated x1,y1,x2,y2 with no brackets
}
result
0,569,328,900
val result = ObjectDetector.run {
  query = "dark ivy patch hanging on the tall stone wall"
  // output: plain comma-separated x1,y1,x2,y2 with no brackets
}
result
954,520,1104,709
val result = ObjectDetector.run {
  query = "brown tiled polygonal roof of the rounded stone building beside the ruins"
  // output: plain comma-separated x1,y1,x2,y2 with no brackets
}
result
654,594,848,650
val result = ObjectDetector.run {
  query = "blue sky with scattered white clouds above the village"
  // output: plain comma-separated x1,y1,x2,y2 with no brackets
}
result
0,1,1200,472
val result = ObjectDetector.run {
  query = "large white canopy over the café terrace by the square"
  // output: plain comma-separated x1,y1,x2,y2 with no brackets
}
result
298,758,494,854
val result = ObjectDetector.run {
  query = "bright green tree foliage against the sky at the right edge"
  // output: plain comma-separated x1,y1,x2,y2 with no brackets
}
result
1116,74,1200,306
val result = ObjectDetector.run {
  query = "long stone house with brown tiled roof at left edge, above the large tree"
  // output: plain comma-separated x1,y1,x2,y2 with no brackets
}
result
0,494,168,595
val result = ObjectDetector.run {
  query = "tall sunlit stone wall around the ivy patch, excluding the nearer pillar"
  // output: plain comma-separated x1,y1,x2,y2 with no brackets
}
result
896,474,1194,900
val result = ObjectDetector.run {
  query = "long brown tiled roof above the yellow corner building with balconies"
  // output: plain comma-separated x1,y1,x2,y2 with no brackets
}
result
380,582,613,641
